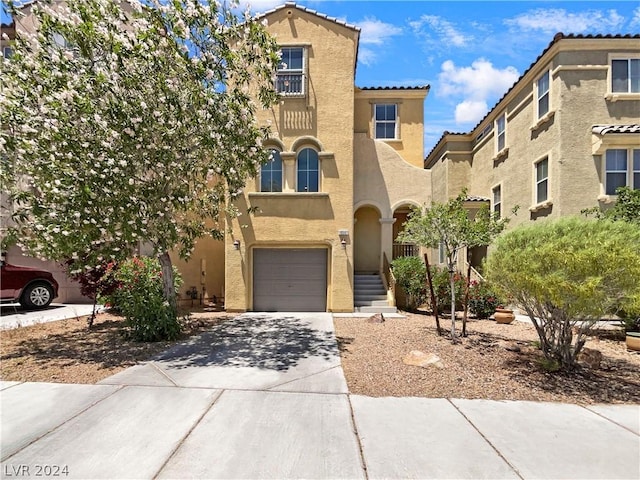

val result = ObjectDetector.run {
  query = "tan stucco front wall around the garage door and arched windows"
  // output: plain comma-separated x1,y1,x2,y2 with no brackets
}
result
225,7,357,311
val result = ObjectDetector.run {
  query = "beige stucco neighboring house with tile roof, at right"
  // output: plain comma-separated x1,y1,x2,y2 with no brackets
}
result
424,33,640,272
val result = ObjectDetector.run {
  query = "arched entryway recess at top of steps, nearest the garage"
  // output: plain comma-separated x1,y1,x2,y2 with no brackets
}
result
353,206,381,274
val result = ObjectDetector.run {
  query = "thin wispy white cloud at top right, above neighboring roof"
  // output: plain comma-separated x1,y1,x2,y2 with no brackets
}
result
504,8,624,34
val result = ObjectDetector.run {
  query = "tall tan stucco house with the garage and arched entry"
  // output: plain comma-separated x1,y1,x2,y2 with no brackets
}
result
176,4,431,312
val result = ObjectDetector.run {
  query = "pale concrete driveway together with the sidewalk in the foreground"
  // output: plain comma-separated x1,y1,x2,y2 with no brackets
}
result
0,313,640,479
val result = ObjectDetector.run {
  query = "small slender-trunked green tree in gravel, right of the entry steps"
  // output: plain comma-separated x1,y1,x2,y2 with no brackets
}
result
400,190,508,342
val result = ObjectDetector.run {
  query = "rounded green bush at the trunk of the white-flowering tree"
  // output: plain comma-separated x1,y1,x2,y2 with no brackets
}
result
101,257,181,342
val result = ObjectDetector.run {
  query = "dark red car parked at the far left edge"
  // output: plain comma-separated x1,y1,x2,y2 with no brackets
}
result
0,262,58,309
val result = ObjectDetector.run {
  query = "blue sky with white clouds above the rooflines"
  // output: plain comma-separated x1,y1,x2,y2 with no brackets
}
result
244,0,640,153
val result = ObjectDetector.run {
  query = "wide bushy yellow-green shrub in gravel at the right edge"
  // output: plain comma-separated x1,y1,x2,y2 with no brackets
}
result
486,218,640,370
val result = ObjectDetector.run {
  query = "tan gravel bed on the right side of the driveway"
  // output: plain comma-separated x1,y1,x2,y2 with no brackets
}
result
335,312,640,404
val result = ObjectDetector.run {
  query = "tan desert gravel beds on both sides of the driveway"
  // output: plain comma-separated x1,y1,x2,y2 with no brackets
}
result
0,311,640,404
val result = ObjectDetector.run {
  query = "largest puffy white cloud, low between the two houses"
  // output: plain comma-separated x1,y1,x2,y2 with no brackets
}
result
437,58,520,123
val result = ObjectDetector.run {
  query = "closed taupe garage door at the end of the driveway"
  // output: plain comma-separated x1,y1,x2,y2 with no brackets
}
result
253,248,327,312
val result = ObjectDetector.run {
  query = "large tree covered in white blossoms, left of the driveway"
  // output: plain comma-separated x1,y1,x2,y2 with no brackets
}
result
0,0,279,326
